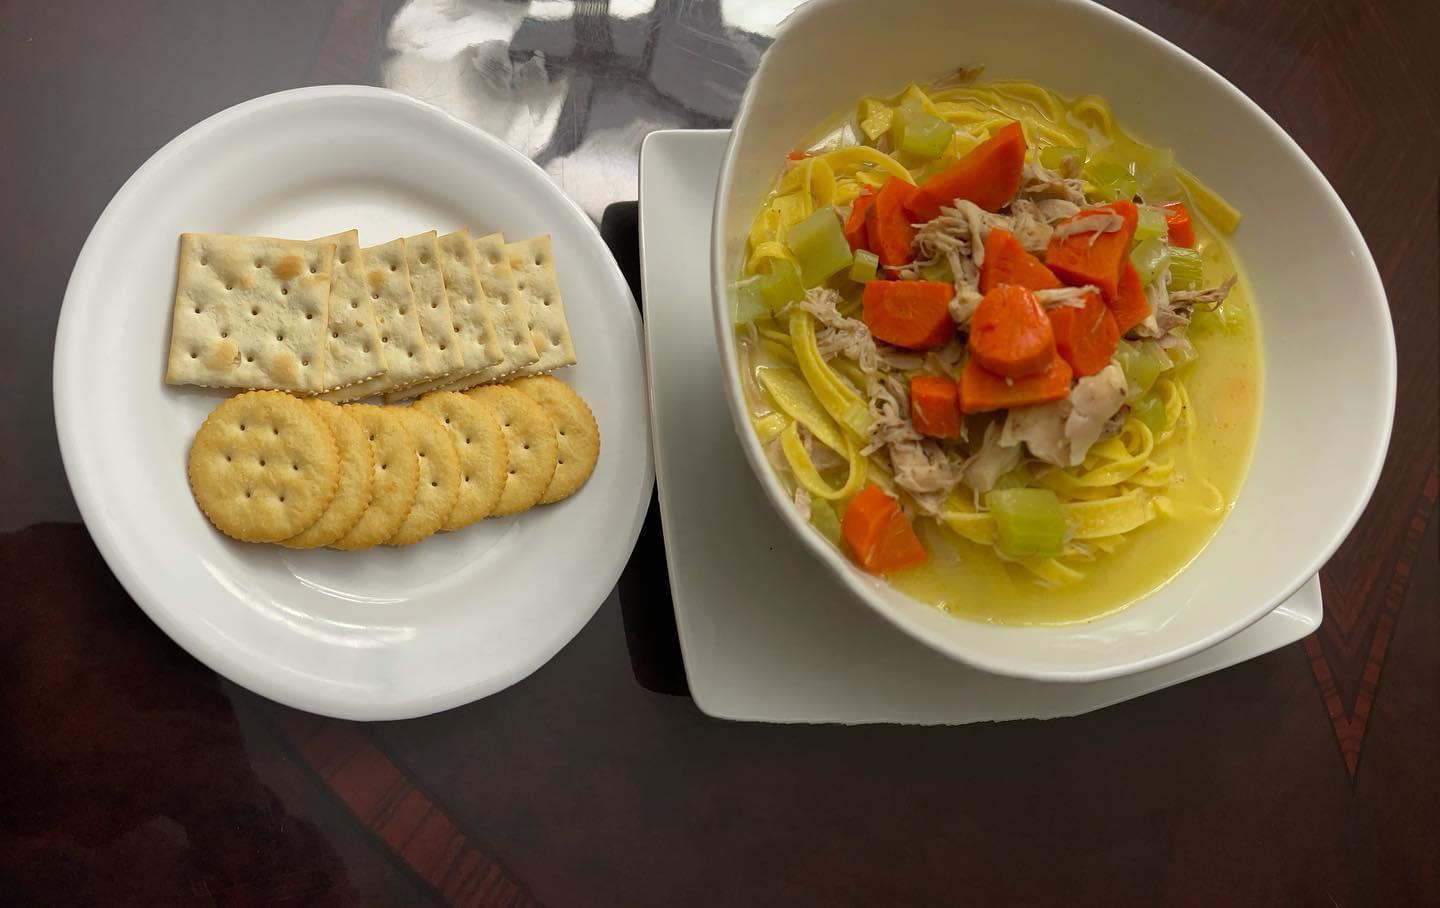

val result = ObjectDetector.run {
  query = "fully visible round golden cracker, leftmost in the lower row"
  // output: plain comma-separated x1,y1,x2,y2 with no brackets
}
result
187,391,340,542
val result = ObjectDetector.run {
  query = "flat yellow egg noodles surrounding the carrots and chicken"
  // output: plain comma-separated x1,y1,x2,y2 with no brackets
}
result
737,82,1238,586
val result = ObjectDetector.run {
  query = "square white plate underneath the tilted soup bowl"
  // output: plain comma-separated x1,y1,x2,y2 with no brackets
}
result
639,130,1322,724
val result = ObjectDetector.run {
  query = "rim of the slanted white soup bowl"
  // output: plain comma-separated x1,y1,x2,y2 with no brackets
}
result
710,0,1397,684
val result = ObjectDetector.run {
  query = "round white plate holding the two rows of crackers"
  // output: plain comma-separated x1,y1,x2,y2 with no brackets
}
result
55,86,652,719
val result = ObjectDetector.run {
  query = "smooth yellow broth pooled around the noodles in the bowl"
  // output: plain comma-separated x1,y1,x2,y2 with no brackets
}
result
736,83,1261,625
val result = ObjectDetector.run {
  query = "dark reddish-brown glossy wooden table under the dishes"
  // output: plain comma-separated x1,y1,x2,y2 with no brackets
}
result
0,0,1440,907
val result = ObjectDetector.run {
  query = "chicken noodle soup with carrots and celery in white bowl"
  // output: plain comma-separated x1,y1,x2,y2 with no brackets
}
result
734,72,1261,625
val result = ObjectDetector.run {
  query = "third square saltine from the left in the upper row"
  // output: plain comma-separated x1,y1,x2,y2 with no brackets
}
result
323,240,433,401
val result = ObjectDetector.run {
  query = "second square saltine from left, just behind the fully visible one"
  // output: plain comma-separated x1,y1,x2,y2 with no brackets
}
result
312,230,384,391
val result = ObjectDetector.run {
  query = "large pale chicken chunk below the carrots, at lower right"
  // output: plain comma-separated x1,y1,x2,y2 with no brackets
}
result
999,363,1126,466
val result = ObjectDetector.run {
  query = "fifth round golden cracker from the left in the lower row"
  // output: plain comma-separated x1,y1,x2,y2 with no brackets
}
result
415,391,510,530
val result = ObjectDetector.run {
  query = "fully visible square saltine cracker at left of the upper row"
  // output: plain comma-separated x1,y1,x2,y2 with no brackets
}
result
166,233,336,393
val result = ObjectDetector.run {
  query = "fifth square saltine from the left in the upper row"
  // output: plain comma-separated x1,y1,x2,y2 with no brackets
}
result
386,230,515,403
